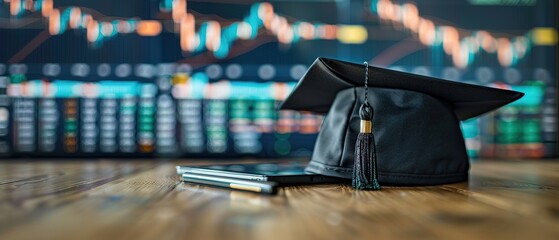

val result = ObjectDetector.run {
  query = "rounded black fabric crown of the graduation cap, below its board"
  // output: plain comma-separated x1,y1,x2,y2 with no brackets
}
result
307,87,469,185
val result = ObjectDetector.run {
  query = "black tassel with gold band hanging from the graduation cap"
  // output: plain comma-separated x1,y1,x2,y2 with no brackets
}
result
352,102,381,190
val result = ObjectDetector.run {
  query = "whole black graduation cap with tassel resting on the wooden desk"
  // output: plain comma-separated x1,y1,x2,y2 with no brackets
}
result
281,58,524,189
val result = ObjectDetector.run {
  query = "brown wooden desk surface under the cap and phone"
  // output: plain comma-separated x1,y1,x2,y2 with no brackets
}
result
0,160,559,240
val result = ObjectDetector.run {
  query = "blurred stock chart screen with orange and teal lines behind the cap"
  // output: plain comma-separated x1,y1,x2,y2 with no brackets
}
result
0,0,558,158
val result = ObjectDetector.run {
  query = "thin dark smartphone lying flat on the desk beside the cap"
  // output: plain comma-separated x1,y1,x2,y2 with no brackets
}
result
176,162,347,186
